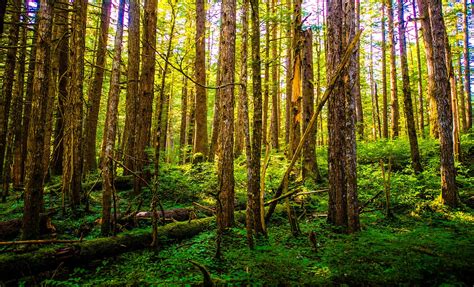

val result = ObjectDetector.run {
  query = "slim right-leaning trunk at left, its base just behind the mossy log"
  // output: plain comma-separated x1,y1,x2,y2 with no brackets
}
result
101,0,125,236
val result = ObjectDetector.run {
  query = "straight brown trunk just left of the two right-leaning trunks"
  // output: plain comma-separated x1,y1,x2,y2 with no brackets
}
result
62,0,88,209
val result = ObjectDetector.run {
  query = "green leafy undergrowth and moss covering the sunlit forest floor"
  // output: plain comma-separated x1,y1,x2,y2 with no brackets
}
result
0,134,474,286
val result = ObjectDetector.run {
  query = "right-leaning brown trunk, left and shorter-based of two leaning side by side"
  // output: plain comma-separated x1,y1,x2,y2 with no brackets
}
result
84,0,112,173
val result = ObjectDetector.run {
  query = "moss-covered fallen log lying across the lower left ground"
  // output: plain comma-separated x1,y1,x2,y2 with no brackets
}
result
0,217,214,282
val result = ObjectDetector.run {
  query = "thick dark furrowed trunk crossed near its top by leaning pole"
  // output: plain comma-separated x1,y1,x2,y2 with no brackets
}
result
326,0,360,232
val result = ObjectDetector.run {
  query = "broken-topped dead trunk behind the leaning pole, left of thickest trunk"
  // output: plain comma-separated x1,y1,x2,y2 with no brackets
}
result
302,30,320,181
